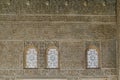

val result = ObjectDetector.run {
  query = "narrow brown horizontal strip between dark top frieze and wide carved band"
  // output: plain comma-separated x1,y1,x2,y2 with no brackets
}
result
0,14,116,22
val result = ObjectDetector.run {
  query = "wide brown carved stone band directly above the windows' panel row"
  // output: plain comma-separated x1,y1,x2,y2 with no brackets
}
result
0,23,117,40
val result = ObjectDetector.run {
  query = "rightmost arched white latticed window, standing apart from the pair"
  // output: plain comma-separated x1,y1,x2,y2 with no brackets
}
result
87,49,98,68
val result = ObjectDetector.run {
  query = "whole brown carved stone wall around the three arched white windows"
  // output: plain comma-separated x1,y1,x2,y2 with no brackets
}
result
0,0,118,80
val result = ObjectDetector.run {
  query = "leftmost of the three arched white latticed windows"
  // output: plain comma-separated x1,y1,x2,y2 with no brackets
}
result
26,48,37,68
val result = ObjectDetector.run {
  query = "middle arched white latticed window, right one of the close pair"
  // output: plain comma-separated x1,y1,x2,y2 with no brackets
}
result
47,49,58,68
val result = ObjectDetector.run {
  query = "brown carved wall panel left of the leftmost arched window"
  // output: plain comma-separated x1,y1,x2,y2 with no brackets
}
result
0,41,24,69
